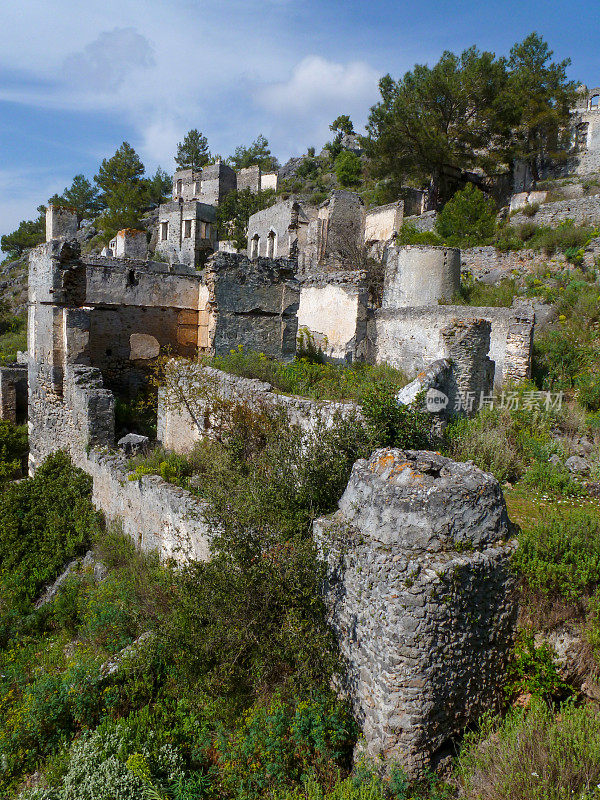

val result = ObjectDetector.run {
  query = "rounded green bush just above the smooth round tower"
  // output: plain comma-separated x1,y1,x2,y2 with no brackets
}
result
435,183,496,247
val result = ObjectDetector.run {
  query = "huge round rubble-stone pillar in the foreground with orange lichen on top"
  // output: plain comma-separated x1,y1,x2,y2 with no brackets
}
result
314,449,517,777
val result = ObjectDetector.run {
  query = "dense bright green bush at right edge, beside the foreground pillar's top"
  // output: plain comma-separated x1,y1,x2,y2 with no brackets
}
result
514,509,600,601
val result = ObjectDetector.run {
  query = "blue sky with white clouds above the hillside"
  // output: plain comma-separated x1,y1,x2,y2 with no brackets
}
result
0,0,600,244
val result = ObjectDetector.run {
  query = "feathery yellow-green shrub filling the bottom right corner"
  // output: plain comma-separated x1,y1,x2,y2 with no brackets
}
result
458,700,600,800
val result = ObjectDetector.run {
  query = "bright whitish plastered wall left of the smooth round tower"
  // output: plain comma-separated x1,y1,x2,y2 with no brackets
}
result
298,270,369,361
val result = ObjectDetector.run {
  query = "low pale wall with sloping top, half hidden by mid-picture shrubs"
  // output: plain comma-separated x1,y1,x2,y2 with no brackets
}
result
157,360,359,453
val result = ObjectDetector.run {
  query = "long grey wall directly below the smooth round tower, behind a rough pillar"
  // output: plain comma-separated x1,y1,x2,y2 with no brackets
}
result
367,304,535,386
